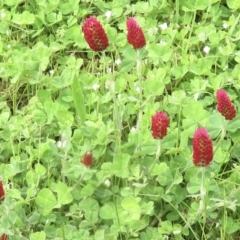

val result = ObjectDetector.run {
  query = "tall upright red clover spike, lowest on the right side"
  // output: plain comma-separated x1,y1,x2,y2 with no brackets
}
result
192,128,213,167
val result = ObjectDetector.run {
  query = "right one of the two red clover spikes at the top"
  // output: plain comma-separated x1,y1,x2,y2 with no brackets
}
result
127,18,146,49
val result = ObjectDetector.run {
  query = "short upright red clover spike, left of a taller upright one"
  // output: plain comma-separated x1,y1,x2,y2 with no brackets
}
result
152,112,169,139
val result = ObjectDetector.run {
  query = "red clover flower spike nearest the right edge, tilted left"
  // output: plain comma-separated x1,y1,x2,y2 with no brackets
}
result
217,89,236,120
